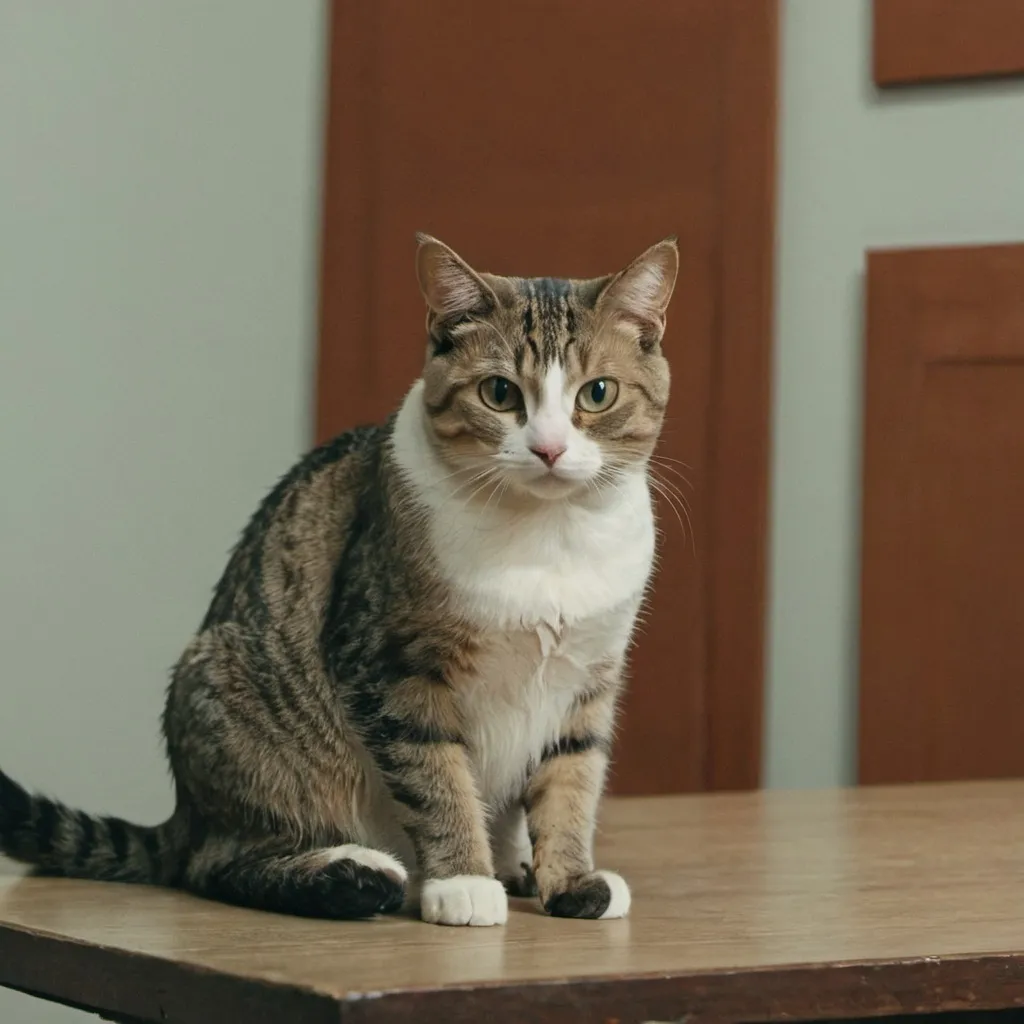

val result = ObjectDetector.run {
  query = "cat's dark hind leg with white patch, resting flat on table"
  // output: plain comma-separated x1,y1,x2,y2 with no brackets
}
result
184,837,408,921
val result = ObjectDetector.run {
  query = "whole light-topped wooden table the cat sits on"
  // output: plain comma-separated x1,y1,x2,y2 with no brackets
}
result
0,782,1024,1024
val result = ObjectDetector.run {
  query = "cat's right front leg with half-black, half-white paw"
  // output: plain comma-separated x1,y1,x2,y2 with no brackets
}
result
525,685,630,918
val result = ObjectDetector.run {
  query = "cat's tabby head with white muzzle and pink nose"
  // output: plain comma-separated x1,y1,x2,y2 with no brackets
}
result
417,234,679,499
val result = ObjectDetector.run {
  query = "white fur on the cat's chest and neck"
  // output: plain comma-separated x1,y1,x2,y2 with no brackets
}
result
395,385,654,803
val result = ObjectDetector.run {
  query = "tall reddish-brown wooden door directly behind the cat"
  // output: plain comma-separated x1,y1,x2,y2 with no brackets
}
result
316,0,775,793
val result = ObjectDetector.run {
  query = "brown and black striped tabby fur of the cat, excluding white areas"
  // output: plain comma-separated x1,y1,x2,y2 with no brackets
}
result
0,240,676,918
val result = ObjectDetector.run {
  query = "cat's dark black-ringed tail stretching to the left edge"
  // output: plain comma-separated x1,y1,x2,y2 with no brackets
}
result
0,771,187,885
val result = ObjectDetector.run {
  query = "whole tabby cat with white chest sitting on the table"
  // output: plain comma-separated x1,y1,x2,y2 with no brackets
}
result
0,234,679,926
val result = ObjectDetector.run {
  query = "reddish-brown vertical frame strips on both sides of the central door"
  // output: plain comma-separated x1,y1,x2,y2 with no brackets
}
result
314,0,778,790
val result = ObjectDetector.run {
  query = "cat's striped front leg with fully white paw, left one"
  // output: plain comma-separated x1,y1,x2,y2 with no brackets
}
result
364,679,508,925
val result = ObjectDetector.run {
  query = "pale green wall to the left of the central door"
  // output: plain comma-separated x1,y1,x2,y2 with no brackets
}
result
0,0,323,1024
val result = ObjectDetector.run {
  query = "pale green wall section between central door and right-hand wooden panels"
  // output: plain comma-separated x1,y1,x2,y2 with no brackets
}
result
766,0,1024,786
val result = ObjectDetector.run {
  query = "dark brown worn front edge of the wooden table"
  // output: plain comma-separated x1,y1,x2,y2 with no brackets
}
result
6,924,1024,1024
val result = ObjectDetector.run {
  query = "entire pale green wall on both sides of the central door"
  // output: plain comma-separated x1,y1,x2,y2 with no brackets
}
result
0,0,1024,1024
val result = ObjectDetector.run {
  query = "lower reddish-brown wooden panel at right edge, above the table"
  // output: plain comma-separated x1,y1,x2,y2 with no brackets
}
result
860,246,1024,782
